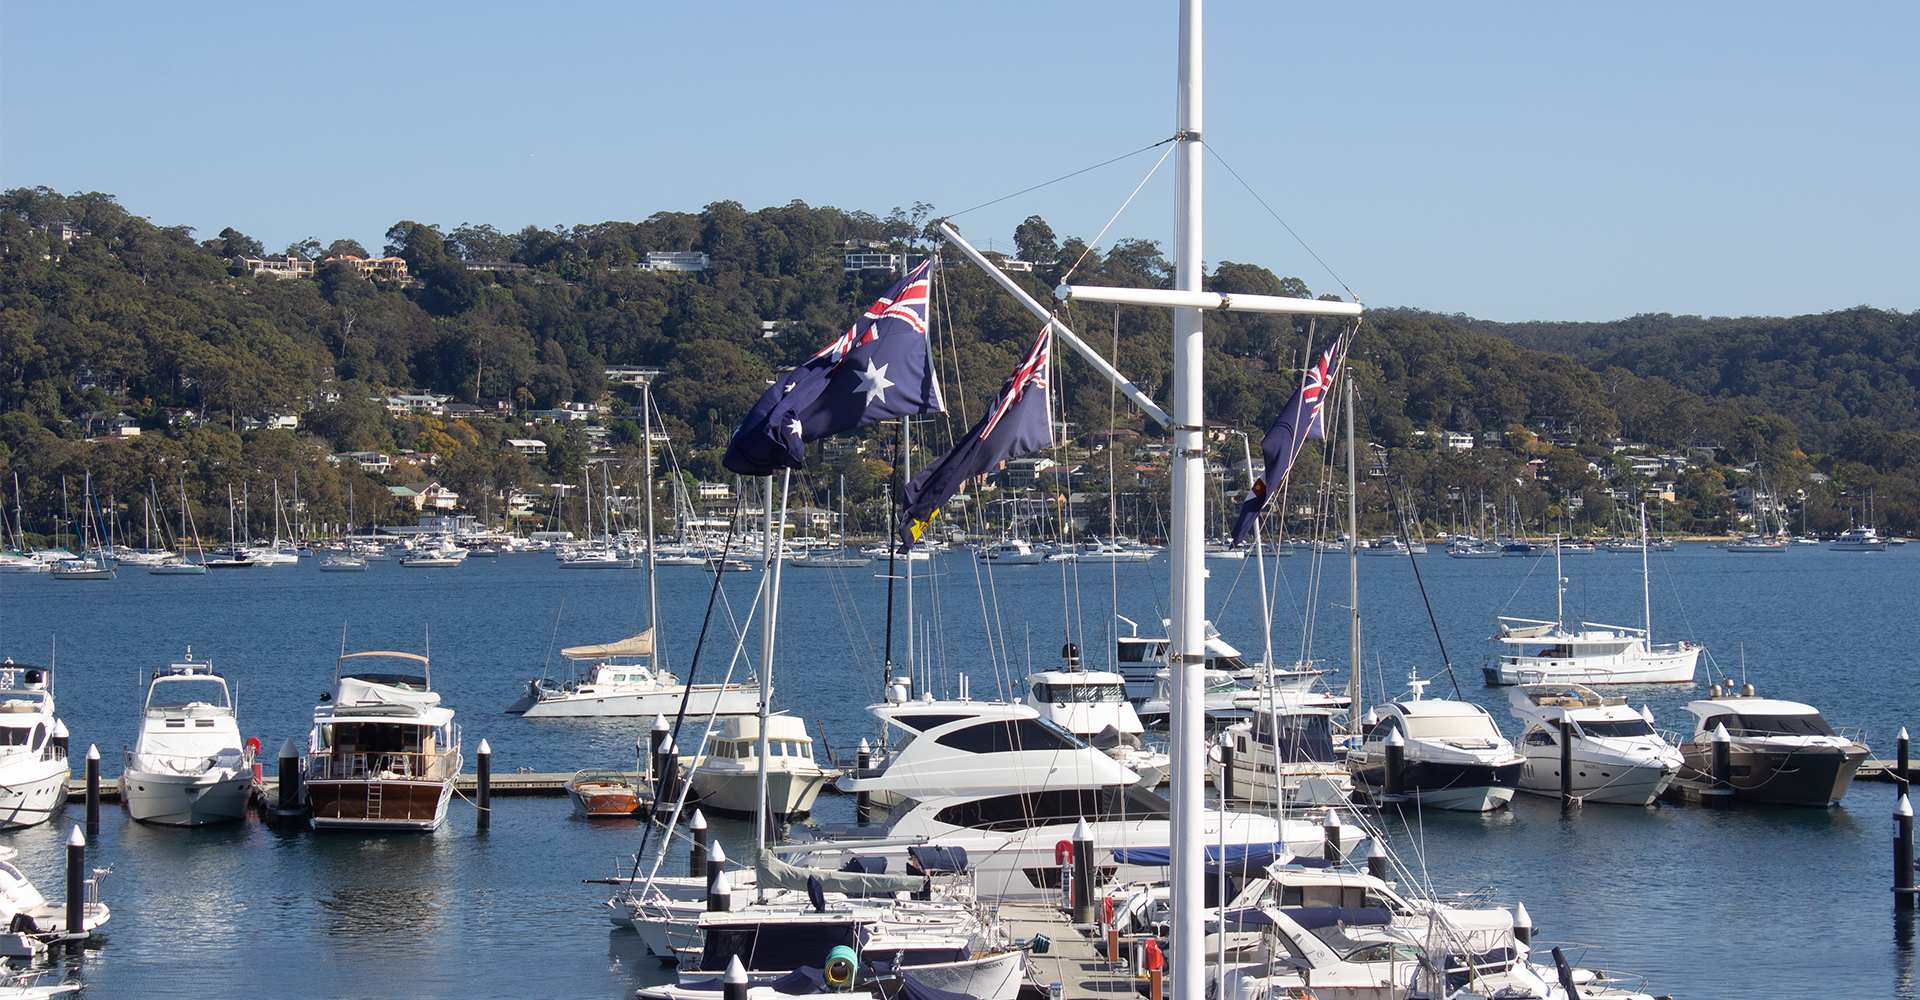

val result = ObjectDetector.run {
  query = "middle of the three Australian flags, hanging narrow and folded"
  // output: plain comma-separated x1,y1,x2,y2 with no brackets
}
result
899,326,1054,549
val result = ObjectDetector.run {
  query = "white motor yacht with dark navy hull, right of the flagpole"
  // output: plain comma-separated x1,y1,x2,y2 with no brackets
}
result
1346,678,1526,812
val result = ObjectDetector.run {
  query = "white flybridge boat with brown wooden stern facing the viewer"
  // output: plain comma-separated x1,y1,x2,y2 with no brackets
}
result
301,651,463,831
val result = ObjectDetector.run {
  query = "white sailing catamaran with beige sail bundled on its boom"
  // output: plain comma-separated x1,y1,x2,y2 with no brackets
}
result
507,628,760,718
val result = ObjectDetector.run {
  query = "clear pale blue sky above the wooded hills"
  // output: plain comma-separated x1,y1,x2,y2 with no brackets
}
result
0,0,1920,321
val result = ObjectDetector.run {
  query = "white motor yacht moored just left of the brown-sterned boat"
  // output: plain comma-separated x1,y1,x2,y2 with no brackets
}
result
119,649,253,827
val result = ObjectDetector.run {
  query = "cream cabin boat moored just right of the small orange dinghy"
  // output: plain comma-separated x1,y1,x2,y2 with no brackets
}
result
684,712,841,820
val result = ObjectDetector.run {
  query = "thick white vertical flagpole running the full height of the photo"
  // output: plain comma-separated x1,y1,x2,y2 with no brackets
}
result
1167,0,1206,1000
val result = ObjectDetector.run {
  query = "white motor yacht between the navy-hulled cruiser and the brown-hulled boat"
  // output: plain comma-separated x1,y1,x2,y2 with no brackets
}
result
1507,683,1680,806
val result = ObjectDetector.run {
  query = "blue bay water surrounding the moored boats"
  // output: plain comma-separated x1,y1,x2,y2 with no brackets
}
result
0,545,1920,998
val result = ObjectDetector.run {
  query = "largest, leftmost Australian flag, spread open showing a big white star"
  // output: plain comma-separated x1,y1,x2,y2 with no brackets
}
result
722,259,947,476
